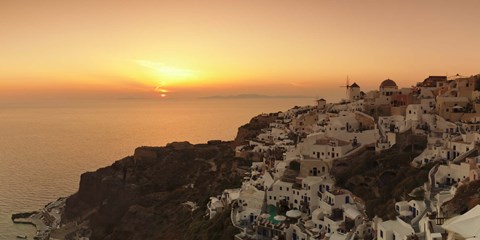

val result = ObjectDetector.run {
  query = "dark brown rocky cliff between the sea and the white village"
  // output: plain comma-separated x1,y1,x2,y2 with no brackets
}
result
64,142,241,239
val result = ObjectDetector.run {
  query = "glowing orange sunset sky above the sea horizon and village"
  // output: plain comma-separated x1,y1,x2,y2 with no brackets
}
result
0,0,480,100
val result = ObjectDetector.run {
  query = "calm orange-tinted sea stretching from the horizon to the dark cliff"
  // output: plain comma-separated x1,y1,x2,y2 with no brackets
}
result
0,98,314,240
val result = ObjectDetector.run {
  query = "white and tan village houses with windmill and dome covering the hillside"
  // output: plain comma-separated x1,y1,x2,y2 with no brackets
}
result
207,75,480,240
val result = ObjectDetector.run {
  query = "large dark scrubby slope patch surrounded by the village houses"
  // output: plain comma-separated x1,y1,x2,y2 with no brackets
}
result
332,133,433,219
